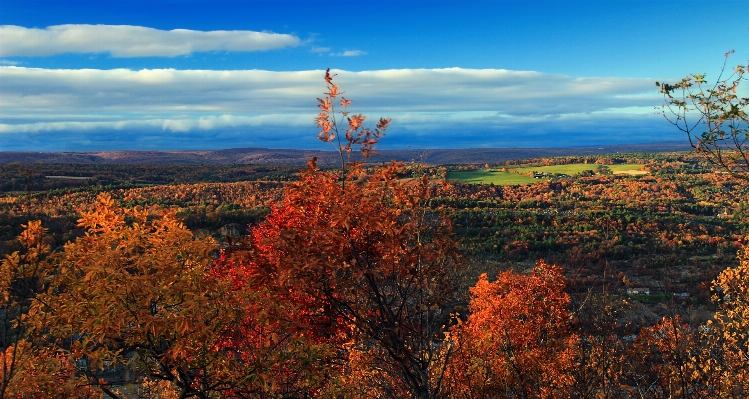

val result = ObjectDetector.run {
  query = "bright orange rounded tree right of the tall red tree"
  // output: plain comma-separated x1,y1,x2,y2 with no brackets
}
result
448,261,576,398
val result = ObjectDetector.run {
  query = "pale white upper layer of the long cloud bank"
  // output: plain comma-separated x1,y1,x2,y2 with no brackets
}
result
0,67,662,118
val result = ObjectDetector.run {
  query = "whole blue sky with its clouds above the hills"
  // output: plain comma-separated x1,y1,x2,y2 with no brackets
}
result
0,0,749,151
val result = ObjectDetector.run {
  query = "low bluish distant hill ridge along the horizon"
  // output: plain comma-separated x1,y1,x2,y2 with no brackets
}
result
0,142,691,166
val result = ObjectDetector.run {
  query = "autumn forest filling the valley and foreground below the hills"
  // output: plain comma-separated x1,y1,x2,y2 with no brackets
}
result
0,67,749,399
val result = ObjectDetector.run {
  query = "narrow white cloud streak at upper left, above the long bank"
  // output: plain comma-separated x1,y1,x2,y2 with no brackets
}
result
0,24,301,57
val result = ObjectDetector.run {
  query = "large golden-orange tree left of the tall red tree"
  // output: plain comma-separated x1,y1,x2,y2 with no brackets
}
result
38,193,251,398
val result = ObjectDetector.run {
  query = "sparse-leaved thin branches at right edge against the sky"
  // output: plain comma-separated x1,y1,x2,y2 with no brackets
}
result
656,51,749,180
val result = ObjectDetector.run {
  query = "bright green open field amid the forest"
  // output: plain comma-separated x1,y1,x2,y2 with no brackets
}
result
447,163,646,186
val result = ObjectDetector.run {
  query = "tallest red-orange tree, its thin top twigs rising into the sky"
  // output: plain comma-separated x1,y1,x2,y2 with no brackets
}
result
213,71,458,398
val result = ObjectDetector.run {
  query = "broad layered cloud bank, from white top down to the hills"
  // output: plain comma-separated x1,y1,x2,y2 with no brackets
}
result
0,67,681,150
